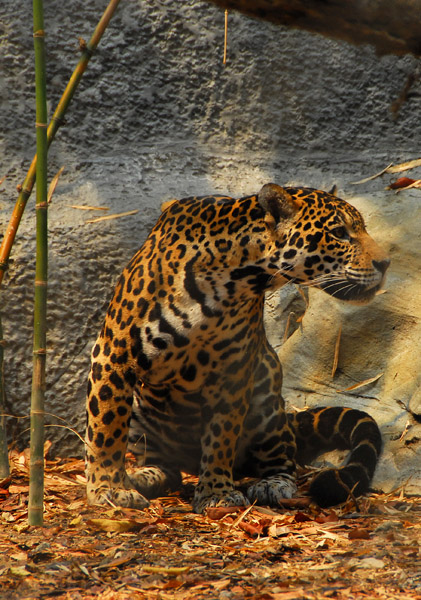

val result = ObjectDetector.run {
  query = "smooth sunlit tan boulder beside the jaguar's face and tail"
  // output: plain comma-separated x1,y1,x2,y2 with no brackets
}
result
266,194,421,494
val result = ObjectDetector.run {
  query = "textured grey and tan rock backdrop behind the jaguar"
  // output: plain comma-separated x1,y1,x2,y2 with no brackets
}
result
0,0,421,493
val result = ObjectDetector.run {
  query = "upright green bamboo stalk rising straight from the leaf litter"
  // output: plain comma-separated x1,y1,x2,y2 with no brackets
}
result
28,0,48,525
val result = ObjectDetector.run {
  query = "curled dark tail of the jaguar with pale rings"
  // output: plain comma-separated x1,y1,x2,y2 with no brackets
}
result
288,406,382,507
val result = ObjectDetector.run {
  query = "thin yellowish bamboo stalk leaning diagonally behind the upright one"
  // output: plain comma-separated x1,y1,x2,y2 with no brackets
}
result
0,0,120,286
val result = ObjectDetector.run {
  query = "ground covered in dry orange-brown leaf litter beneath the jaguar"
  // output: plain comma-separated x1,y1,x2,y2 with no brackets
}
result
0,451,421,600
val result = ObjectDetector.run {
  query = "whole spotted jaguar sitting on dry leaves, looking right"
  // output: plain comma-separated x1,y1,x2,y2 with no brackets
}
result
86,183,389,513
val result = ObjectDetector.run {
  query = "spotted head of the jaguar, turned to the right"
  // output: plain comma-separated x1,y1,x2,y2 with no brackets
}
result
258,184,390,304
